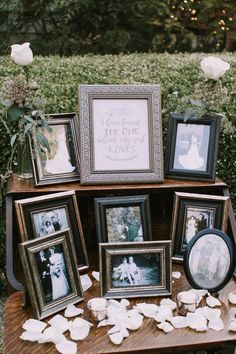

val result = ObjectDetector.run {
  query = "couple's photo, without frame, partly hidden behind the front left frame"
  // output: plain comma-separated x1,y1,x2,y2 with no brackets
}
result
32,208,70,237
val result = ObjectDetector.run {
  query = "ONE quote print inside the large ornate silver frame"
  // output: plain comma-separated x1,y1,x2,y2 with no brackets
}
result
93,99,150,171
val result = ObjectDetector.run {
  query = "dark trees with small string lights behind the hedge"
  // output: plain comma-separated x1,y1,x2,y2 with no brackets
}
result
0,0,236,55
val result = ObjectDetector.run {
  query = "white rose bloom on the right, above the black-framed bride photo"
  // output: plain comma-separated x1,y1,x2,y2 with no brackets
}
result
201,56,230,80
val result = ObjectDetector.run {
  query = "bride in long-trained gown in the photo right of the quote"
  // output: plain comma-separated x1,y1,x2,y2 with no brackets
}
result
178,134,204,170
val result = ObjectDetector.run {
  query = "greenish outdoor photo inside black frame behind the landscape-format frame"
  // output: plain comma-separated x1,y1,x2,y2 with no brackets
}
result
106,206,143,242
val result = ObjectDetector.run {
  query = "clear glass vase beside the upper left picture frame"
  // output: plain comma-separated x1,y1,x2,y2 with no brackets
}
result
17,137,33,179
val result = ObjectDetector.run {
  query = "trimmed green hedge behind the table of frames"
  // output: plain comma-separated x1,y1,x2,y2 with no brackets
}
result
0,54,236,286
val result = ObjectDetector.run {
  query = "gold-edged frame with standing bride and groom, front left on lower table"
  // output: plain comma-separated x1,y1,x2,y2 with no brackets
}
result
19,229,83,319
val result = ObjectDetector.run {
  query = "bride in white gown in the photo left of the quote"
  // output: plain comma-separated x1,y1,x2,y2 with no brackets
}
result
44,127,75,174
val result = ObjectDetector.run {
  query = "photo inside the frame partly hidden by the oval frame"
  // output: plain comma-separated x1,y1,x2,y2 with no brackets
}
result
183,206,215,247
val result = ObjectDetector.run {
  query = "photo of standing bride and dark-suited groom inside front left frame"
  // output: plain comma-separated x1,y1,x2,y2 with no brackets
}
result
36,245,71,303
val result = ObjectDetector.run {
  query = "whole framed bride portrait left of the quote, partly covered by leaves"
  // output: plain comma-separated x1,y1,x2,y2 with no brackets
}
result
31,113,79,186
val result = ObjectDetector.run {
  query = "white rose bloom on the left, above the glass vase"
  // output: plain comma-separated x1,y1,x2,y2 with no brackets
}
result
11,42,33,66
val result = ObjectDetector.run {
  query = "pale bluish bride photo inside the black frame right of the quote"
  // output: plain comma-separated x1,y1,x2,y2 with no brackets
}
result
173,123,210,171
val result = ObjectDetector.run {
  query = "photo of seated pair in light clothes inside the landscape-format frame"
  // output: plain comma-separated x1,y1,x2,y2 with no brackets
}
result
112,253,161,288
